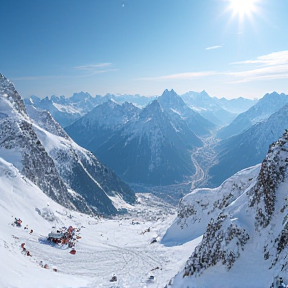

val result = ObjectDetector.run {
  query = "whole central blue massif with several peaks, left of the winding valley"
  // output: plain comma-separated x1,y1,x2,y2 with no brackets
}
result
65,90,208,185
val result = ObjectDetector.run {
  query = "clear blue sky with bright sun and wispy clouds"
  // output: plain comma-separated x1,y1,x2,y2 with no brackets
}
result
0,0,288,99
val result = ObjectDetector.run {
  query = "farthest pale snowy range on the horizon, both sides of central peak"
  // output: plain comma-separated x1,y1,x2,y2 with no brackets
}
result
24,91,256,127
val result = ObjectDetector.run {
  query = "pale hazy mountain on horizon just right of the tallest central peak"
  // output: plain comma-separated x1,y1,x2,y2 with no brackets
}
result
181,91,236,126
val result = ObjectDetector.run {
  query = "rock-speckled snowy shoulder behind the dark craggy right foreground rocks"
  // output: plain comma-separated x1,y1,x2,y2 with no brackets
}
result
162,165,260,246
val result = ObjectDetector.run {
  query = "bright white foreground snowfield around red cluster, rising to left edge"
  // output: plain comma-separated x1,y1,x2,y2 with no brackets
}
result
0,158,199,288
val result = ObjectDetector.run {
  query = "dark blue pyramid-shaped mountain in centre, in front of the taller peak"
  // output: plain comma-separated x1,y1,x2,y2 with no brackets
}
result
92,100,202,185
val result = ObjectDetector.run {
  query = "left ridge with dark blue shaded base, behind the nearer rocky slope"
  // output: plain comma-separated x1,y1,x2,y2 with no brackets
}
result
27,106,135,215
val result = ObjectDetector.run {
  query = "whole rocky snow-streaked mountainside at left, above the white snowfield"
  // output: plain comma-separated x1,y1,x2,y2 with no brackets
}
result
0,75,135,214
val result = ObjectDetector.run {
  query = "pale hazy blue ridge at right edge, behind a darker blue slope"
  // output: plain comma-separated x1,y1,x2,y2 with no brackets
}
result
217,92,288,139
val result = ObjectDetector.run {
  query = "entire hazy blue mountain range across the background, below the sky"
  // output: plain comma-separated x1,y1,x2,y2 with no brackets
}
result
26,85,288,192
